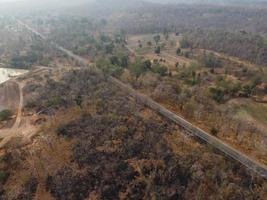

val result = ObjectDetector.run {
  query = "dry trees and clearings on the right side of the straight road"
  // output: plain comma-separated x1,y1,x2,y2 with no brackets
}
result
27,13,267,165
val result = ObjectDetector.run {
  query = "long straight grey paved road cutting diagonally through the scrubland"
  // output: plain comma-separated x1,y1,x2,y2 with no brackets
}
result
16,19,267,178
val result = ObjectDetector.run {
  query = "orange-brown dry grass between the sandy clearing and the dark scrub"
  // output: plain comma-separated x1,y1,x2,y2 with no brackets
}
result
2,107,88,200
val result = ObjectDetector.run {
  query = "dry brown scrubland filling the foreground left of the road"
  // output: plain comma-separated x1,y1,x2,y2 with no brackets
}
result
0,69,266,199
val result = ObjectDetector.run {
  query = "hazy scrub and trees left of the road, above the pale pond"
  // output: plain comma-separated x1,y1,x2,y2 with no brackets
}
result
0,18,58,69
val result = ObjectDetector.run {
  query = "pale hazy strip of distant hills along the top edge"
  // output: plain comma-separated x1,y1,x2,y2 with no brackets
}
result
3,0,267,16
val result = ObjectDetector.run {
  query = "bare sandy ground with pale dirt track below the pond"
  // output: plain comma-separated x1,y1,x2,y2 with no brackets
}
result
0,68,50,149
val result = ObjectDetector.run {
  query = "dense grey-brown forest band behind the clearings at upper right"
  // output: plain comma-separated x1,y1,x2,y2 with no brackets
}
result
185,29,267,66
